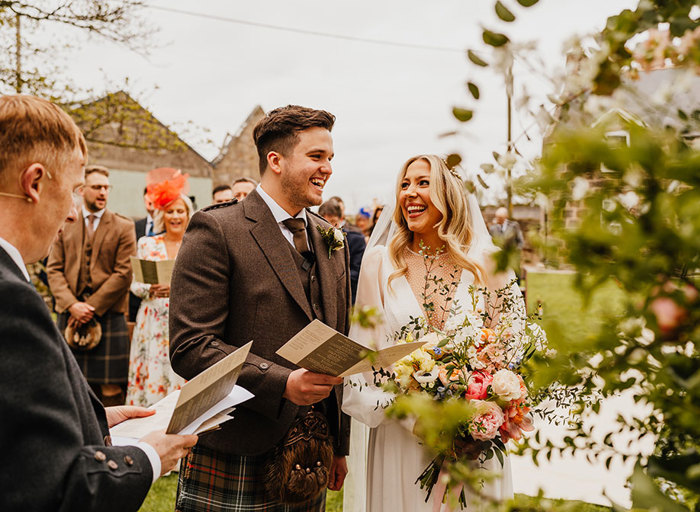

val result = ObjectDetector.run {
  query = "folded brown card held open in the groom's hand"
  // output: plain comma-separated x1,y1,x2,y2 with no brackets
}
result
277,320,424,377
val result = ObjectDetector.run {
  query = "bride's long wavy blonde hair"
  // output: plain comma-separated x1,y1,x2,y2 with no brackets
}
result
389,155,486,285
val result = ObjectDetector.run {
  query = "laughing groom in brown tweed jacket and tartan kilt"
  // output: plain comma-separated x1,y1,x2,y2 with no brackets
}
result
170,105,350,512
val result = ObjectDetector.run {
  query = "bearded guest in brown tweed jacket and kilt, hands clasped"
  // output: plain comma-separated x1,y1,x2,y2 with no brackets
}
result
47,165,136,405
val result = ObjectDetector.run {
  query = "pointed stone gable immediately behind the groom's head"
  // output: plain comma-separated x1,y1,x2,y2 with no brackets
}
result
212,105,265,186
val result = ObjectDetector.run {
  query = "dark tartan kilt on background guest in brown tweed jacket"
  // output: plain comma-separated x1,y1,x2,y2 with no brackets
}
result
58,312,129,385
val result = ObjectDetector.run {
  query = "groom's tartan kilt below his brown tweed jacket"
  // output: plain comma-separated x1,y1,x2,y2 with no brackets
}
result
175,446,326,512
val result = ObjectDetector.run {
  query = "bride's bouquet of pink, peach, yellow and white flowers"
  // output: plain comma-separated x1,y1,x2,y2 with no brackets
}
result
379,282,546,506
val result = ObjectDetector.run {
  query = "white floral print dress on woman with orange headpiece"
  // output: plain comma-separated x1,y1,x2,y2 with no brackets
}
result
126,235,185,407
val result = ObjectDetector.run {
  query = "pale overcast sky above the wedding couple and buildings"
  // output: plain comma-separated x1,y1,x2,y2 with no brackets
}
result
61,0,636,209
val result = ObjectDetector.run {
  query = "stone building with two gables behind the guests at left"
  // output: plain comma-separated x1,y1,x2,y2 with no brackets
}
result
67,91,265,218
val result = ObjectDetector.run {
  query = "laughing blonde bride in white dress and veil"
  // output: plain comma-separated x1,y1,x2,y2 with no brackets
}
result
343,155,513,512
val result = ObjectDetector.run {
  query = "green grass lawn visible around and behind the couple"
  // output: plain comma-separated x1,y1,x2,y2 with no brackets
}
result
141,272,620,512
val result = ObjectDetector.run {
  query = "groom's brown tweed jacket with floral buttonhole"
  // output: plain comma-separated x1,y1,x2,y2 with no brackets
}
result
170,191,350,455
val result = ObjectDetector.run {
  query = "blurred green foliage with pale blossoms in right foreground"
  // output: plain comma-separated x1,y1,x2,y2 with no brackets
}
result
396,0,700,512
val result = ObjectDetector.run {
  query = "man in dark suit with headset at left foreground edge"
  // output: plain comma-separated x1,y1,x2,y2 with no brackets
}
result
0,96,197,512
